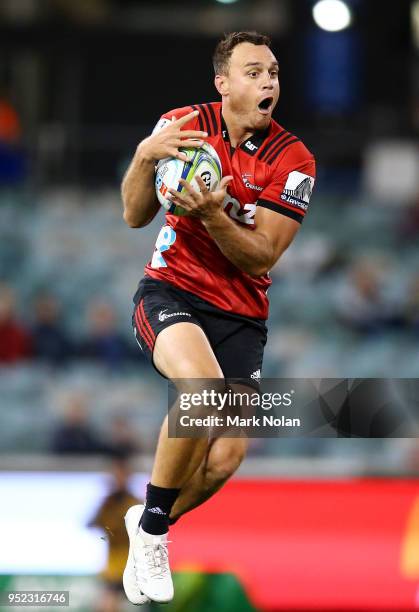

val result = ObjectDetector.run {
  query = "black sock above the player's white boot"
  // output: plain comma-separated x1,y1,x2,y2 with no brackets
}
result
140,482,180,535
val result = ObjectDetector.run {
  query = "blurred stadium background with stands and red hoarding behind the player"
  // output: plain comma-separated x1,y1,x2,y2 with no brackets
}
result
0,0,419,612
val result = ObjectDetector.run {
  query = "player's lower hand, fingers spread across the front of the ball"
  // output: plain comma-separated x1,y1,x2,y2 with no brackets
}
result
166,176,233,221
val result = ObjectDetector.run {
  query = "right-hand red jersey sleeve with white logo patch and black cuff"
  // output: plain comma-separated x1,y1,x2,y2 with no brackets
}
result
257,142,316,223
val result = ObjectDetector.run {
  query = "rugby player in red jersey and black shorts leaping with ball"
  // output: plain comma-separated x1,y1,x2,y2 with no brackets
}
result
122,32,315,604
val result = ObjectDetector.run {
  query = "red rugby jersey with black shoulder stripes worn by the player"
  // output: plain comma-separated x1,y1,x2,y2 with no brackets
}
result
145,102,315,319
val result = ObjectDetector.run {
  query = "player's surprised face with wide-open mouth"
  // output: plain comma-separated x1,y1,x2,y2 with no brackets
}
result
221,42,279,129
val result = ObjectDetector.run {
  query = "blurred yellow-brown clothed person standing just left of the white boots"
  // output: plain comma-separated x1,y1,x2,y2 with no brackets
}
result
89,458,142,612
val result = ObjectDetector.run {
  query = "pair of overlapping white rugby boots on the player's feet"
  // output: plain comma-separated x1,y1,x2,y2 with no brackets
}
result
125,506,174,603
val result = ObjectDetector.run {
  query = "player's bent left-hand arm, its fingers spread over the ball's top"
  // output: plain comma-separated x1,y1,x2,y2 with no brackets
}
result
121,111,207,227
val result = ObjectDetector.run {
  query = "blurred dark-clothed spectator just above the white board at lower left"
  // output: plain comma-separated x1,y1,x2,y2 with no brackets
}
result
51,395,106,455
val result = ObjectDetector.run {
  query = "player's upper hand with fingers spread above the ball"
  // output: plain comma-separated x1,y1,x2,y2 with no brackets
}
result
137,111,208,162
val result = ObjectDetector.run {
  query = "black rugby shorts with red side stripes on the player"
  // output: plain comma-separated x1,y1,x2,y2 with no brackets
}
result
132,276,267,386
